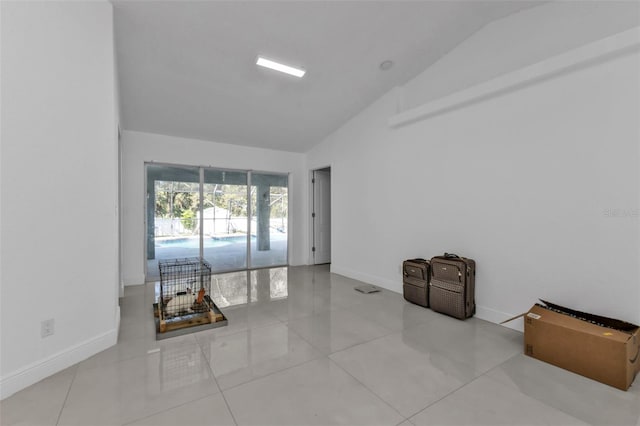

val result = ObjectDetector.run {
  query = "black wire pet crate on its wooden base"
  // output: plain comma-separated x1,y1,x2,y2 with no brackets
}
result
156,258,227,339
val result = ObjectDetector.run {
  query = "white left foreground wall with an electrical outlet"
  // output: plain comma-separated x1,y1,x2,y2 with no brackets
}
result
0,2,119,398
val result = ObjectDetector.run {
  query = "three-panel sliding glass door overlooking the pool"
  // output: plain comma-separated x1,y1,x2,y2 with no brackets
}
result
146,164,288,280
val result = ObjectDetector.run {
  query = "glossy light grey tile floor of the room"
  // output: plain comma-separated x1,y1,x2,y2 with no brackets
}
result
0,266,640,426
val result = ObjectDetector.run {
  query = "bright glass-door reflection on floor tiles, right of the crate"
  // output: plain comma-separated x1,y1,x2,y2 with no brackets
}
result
211,267,288,308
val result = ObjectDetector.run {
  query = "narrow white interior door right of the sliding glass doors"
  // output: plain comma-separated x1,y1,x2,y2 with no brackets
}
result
311,168,331,265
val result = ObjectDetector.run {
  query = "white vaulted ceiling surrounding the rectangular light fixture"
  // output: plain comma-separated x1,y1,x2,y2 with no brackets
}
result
112,0,540,152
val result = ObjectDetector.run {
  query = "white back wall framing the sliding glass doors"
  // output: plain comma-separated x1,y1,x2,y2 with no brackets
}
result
122,131,308,285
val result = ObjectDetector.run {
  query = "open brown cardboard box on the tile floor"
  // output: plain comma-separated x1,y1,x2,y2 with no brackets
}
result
524,301,640,391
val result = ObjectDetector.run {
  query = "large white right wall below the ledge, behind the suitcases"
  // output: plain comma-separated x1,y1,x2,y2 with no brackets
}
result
307,3,640,328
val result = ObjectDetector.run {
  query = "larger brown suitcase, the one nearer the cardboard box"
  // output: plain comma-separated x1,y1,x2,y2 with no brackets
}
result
429,253,476,319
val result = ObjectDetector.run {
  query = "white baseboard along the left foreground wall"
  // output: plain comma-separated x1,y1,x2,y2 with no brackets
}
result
0,318,120,400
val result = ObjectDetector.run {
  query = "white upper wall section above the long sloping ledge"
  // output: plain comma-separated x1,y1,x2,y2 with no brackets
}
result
402,0,640,108
